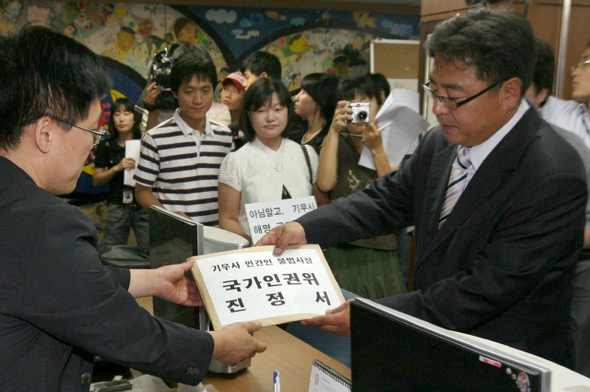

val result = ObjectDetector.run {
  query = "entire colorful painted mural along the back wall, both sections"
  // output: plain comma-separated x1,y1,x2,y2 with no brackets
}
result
0,0,419,88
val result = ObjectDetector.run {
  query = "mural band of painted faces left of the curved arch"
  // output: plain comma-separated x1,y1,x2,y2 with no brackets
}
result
0,1,226,77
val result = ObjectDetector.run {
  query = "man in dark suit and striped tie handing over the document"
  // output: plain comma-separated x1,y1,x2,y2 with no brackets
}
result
260,9,586,366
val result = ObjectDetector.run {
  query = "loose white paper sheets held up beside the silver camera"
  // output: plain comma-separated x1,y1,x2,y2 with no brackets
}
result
359,88,428,170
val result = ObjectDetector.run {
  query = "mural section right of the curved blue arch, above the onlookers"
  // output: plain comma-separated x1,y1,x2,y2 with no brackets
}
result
180,6,419,80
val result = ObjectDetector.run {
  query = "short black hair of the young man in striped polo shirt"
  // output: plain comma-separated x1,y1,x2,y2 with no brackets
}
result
170,44,217,94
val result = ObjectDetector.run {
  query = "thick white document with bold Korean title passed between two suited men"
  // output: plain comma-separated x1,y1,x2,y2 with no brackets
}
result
192,245,344,330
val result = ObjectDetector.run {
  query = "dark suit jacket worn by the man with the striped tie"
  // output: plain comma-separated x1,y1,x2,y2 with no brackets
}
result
299,105,586,366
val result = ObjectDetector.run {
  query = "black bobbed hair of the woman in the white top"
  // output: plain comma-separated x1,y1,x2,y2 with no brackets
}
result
240,78,295,142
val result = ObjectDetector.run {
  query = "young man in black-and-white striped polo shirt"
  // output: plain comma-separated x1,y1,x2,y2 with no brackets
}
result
135,50,233,226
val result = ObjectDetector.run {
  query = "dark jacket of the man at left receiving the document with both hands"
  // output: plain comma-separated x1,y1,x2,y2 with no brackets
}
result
0,157,213,391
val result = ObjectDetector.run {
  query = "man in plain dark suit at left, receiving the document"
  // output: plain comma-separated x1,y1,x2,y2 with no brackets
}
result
0,27,265,391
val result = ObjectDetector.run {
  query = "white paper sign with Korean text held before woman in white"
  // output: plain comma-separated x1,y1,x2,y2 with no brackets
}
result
244,196,318,244
